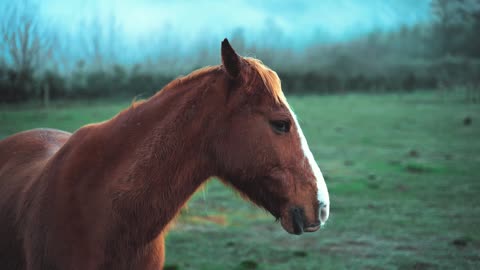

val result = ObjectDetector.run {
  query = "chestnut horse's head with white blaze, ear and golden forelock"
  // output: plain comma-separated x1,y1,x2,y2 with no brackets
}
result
215,39,330,234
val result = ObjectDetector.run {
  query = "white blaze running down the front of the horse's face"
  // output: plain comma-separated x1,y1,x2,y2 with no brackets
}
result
287,106,330,224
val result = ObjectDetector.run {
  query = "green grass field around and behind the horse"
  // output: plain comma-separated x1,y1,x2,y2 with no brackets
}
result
0,92,480,269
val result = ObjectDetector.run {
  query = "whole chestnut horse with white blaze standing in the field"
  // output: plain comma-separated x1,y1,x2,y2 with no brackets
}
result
0,39,329,270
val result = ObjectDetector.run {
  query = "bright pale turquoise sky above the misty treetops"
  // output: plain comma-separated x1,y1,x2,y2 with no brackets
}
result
40,0,430,44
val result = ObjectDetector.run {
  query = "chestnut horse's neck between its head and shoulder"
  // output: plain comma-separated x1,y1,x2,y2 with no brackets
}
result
79,73,219,244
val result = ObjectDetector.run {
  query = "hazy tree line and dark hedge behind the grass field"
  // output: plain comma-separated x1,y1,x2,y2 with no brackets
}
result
0,0,480,103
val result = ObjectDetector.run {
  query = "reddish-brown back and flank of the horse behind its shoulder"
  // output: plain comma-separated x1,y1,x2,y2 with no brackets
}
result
0,129,71,269
